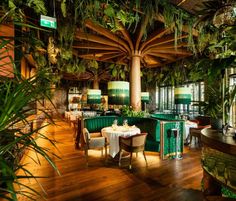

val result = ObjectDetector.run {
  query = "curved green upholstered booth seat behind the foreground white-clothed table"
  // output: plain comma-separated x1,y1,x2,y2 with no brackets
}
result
82,116,184,159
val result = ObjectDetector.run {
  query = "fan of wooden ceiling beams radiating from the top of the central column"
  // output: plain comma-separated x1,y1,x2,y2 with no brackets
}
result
73,0,205,68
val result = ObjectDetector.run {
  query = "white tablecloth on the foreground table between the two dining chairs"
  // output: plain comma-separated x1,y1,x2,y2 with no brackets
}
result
101,126,140,158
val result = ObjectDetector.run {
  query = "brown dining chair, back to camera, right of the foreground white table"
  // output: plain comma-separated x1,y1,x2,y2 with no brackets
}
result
119,133,147,169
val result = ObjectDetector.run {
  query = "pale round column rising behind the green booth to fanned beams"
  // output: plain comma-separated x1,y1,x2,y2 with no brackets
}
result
130,52,141,111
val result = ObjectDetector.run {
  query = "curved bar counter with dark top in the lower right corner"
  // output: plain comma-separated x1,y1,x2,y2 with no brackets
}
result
201,128,236,198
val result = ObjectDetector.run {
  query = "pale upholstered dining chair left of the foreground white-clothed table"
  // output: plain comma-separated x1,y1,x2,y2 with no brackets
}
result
82,128,107,166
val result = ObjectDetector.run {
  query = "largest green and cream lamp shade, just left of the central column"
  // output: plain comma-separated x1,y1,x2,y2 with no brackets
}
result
108,81,129,105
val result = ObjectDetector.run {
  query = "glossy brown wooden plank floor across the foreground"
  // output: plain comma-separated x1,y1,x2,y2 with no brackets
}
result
19,121,204,201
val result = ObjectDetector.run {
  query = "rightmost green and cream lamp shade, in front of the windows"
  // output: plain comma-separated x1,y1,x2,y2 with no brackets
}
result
175,87,191,104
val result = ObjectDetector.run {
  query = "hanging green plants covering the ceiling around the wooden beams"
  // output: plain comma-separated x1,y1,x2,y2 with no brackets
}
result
2,0,236,84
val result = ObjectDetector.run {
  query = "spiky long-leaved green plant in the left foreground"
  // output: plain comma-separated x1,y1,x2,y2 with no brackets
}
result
0,68,59,200
